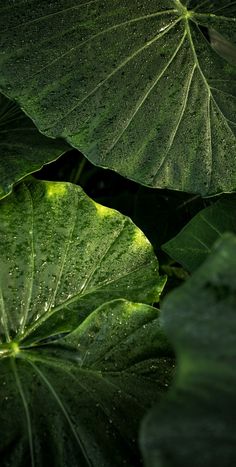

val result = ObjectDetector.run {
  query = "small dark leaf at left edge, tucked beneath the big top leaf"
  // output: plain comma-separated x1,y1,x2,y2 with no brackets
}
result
0,94,70,199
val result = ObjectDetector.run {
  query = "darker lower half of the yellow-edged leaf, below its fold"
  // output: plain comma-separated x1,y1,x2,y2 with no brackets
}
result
0,300,173,467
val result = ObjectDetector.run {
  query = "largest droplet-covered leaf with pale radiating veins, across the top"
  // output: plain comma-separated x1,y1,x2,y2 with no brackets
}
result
0,0,236,195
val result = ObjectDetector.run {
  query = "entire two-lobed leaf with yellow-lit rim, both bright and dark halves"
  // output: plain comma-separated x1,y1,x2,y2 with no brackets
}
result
0,180,173,467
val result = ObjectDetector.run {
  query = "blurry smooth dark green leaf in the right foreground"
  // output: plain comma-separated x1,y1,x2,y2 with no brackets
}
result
141,234,236,467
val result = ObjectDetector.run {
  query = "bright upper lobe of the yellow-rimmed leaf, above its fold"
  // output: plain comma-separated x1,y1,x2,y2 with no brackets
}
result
0,181,165,341
